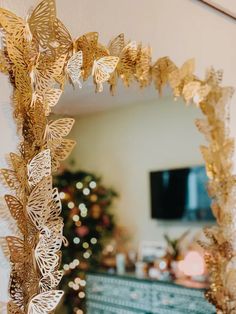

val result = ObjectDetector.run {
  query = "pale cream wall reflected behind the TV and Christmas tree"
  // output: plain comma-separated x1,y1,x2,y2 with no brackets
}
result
68,97,208,247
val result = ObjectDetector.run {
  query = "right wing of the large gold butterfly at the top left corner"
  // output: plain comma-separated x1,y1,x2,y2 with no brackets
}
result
28,0,56,49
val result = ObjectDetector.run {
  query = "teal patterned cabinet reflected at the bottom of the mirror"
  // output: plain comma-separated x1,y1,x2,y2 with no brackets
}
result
86,273,215,314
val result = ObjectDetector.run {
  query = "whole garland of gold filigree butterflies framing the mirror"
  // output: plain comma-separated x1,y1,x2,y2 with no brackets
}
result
0,0,236,314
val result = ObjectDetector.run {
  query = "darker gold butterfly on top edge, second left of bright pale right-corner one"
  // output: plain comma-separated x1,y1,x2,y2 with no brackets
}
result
152,57,177,94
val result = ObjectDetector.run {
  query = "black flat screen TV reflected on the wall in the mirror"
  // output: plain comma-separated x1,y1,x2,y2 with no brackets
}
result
150,166,214,221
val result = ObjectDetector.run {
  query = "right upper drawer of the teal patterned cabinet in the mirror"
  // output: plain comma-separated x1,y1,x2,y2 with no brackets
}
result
152,283,215,314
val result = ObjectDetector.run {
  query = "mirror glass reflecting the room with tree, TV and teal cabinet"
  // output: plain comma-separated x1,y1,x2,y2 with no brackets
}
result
53,82,215,314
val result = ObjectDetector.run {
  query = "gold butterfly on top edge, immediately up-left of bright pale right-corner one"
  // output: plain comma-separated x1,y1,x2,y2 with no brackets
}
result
169,59,195,97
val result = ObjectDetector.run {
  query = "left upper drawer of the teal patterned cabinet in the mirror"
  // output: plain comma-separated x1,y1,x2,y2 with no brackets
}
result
86,274,152,313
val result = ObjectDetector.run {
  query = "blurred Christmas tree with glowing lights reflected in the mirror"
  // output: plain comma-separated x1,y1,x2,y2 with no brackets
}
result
55,171,117,314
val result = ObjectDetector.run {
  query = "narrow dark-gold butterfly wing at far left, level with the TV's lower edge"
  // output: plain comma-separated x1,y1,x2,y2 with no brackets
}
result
4,195,27,235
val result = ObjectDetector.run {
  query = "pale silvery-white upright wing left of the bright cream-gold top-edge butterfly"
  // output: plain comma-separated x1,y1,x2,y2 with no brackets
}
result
66,50,83,88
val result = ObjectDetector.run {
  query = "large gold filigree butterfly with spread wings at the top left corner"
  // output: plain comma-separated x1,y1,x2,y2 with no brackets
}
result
0,0,56,49
